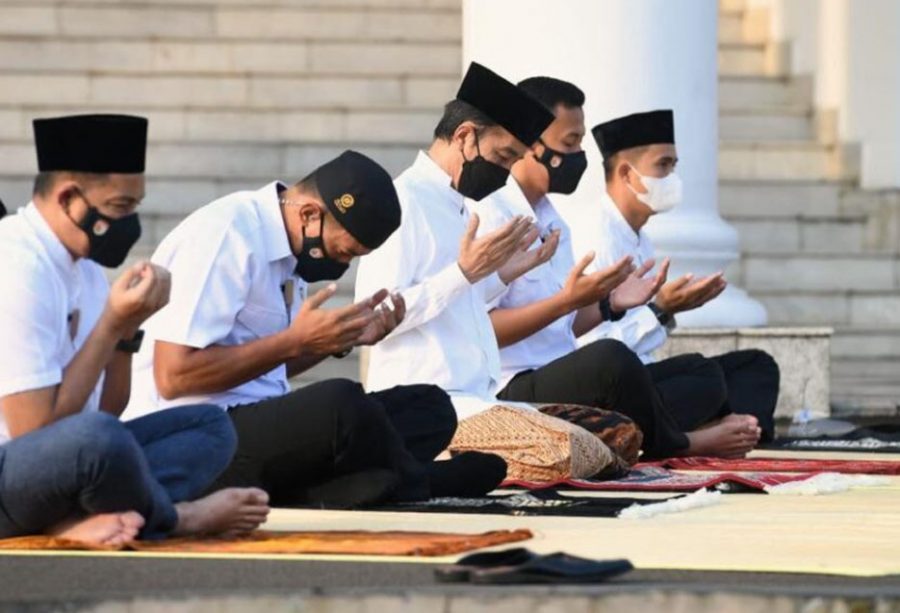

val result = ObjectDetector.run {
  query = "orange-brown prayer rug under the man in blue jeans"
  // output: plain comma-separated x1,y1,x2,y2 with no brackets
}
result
0,530,533,557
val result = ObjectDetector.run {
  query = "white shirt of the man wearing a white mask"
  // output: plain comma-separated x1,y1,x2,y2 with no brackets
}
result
576,191,668,364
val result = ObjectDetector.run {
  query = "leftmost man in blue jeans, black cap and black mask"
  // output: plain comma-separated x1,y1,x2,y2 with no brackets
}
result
0,115,268,547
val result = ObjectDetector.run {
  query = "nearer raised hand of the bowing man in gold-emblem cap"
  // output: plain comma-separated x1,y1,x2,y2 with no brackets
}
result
288,283,376,355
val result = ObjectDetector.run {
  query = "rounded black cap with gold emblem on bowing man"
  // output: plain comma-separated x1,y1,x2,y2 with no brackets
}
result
315,150,400,249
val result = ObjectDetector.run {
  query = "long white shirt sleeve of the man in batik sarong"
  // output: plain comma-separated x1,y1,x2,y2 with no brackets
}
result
355,206,470,336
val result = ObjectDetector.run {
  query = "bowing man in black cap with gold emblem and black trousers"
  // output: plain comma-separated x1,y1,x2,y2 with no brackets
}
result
126,151,505,508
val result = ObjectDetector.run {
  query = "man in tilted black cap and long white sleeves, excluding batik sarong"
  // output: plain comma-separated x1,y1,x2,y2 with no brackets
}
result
356,62,555,418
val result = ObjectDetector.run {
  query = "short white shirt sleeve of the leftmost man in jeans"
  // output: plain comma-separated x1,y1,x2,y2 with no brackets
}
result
0,261,65,398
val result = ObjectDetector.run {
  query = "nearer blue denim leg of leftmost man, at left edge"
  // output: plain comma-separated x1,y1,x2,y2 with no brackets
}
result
0,413,177,538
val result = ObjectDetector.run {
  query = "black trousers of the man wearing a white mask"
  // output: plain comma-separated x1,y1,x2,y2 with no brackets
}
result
648,349,781,442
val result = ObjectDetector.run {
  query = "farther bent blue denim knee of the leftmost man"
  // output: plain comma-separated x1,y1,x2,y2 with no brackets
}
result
125,405,237,502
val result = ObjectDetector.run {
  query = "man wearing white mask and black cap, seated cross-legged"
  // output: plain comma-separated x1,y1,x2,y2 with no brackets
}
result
579,110,779,440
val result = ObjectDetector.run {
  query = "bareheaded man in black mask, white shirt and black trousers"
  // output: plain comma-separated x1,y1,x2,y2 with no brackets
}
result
481,77,760,457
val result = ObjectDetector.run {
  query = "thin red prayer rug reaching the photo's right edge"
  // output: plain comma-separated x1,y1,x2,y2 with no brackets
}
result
652,457,900,475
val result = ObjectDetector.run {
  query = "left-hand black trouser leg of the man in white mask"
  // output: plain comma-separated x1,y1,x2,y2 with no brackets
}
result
647,353,731,432
